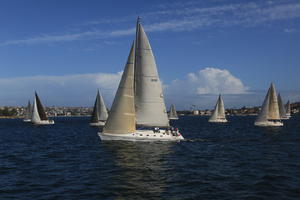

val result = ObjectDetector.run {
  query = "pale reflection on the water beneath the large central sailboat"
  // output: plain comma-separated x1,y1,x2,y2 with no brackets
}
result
102,141,176,199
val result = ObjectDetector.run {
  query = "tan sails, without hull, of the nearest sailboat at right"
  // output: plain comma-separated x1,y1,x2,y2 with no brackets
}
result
256,83,280,122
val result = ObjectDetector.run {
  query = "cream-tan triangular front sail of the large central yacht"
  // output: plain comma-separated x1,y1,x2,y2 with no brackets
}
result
103,44,136,134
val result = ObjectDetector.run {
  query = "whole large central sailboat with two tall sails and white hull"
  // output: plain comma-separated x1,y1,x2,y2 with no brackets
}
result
99,19,184,141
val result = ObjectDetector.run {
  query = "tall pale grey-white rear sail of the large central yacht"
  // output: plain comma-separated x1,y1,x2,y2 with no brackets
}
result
134,21,169,127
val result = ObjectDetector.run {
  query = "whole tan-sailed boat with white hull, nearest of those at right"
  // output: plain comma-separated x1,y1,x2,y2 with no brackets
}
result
254,83,283,126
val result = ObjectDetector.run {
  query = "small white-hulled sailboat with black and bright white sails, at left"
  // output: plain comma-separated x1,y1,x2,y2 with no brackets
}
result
31,92,54,125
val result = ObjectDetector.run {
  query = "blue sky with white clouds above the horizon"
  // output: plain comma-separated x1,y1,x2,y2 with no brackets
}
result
0,0,300,108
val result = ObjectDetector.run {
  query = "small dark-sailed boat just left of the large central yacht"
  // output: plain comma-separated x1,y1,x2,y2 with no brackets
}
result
90,90,108,126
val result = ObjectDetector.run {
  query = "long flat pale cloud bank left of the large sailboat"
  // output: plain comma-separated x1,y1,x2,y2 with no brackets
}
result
0,72,122,106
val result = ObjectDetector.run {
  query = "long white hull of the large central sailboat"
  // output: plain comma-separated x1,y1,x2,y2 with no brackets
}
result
98,130,184,141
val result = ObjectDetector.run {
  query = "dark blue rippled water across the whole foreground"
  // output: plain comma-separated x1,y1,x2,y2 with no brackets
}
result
0,116,300,200
